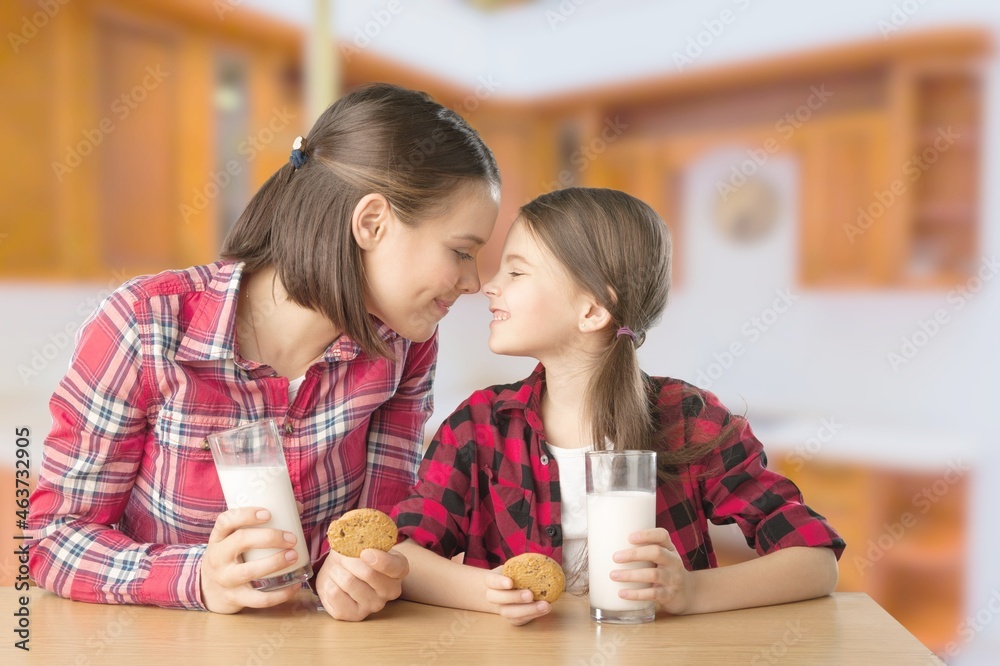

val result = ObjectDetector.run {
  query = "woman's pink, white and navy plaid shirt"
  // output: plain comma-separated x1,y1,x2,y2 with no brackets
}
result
28,262,437,608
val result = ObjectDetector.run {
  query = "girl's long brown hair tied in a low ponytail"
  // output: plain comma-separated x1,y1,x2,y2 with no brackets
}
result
520,188,736,480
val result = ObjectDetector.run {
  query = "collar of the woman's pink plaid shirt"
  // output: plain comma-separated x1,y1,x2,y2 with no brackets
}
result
175,261,399,362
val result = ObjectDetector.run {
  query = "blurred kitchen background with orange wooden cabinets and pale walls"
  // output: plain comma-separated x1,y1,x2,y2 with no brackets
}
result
0,0,1000,664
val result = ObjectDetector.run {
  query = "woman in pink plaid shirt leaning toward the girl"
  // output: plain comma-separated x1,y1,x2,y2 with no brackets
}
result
28,85,500,620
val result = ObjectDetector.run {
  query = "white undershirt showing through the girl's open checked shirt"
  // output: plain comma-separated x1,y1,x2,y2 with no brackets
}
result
548,444,591,593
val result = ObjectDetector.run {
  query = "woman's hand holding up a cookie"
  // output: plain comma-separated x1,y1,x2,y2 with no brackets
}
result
316,548,410,622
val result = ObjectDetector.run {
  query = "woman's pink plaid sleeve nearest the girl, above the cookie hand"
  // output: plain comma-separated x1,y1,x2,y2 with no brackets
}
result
360,333,438,513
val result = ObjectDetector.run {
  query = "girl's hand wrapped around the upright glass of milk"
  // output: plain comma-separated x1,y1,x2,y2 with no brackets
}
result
611,527,694,615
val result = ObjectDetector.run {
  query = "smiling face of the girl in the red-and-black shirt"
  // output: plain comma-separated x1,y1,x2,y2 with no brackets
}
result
483,219,591,363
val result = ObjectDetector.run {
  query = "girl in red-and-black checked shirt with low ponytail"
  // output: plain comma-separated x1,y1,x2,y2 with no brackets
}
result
393,189,844,624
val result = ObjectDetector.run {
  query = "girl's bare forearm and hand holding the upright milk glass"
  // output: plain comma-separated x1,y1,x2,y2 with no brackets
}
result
611,528,837,615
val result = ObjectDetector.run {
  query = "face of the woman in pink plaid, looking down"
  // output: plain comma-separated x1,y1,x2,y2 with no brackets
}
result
363,189,500,342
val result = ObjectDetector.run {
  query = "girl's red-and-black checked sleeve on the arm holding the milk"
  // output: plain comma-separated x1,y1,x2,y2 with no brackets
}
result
693,392,845,559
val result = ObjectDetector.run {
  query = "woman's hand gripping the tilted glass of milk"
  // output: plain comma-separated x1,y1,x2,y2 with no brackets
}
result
200,507,299,613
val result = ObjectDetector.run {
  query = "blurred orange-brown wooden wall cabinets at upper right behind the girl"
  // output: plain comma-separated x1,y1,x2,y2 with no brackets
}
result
540,31,990,289
